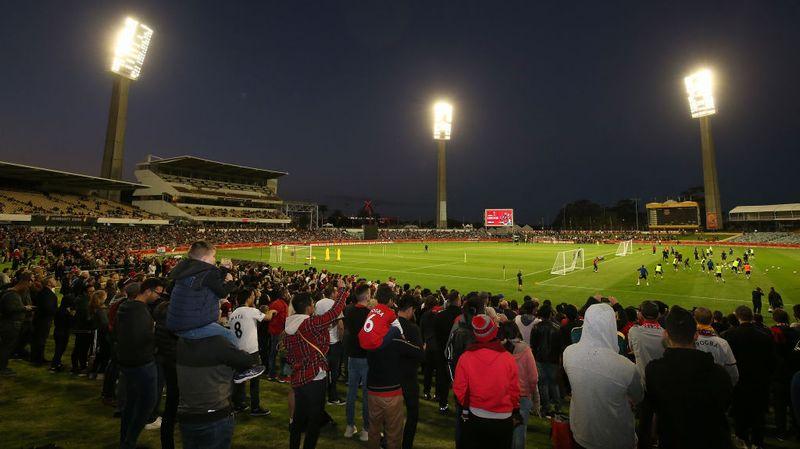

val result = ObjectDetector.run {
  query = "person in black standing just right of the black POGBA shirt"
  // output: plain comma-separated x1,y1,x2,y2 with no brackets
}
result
722,306,775,446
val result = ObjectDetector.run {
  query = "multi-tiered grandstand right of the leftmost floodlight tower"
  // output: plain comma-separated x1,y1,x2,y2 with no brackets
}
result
133,156,291,225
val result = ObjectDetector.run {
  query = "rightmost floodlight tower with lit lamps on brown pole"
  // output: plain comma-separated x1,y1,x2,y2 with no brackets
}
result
684,69,722,230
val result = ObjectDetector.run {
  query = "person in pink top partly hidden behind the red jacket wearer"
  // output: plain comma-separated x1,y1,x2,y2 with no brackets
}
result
500,322,540,449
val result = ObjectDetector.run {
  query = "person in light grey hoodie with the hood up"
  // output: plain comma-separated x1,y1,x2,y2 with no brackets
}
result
564,303,644,449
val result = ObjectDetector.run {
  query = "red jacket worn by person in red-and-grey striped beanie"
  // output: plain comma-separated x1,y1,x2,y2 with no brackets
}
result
453,341,519,413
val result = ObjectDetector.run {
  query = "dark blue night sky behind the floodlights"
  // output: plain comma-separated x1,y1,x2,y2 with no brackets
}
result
0,0,800,224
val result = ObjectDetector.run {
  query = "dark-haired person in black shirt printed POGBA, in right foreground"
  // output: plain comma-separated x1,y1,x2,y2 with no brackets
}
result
640,306,733,449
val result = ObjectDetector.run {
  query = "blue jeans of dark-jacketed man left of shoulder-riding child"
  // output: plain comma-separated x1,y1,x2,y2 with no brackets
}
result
119,362,158,449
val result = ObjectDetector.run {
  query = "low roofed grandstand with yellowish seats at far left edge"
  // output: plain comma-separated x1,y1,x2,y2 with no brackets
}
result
0,162,167,225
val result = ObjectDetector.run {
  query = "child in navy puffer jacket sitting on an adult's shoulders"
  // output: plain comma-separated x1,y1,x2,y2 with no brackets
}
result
167,240,236,344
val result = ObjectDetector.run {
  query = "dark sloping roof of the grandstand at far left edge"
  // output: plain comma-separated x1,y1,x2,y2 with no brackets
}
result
0,161,147,190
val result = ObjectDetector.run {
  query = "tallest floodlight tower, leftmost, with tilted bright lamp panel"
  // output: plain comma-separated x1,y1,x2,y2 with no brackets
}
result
100,17,153,198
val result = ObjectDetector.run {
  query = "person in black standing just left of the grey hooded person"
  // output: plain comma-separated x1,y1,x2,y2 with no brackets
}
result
531,304,563,416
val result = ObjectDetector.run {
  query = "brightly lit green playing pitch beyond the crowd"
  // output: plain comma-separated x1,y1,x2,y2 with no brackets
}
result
218,242,800,319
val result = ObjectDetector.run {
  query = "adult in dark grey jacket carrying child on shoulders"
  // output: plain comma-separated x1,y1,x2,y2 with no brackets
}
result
175,300,256,449
